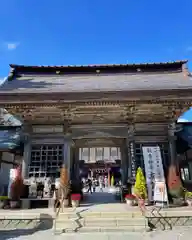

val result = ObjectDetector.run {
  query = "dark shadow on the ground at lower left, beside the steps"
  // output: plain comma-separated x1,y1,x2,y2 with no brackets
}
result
0,214,53,240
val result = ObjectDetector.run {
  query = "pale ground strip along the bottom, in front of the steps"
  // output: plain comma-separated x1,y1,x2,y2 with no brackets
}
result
0,228,192,240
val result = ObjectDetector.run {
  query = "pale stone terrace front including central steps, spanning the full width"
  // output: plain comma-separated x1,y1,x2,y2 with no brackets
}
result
0,204,192,234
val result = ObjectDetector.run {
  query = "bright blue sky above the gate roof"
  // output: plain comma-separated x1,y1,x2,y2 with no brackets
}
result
0,0,192,119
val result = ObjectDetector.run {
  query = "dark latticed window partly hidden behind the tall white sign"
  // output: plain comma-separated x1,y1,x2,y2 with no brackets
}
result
135,143,169,172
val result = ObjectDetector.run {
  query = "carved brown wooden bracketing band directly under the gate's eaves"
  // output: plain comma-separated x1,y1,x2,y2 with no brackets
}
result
1,100,192,124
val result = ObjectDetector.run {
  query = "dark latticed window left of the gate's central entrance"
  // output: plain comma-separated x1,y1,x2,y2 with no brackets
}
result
29,145,63,178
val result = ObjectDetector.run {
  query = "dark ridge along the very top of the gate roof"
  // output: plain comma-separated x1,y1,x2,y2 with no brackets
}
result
10,60,187,74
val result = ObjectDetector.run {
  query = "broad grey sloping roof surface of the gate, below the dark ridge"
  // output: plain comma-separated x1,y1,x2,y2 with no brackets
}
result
0,72,192,93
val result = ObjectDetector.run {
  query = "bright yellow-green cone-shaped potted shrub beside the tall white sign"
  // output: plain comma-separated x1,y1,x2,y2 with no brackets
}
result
133,167,147,199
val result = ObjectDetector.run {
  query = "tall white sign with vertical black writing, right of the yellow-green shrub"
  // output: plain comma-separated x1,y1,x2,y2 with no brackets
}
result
142,146,168,202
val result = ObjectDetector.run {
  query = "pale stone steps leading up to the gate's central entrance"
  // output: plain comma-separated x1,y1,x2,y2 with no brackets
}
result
55,211,146,234
